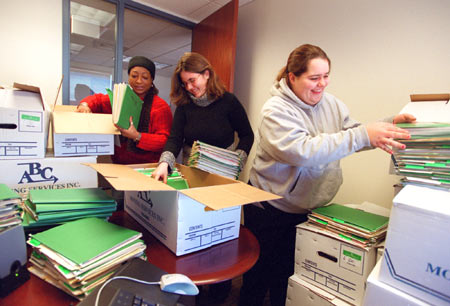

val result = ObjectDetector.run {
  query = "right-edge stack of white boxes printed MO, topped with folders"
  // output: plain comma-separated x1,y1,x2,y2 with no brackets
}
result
364,94,450,305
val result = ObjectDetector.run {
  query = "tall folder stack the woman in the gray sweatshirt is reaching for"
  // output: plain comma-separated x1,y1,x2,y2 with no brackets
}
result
393,119,450,189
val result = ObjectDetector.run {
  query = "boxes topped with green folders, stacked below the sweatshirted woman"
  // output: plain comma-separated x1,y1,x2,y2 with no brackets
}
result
286,203,388,305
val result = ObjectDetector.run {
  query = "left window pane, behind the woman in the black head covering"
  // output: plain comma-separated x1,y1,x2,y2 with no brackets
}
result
70,0,116,105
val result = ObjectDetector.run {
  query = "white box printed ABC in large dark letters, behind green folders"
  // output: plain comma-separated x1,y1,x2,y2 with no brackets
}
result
0,156,98,199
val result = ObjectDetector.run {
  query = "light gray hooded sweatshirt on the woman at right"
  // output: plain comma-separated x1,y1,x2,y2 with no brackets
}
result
250,78,370,213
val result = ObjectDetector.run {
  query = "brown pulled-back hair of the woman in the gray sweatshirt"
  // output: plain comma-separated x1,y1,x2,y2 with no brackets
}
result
277,44,331,85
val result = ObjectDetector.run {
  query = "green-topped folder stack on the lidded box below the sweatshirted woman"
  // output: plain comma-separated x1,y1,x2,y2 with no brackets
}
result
308,204,389,250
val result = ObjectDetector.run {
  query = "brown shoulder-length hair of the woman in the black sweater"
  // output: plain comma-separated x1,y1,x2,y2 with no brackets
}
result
170,52,226,106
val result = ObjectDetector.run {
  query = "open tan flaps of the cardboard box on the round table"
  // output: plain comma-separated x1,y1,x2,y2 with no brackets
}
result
84,164,281,210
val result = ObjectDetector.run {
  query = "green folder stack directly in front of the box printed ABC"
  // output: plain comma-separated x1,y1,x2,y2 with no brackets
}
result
22,188,117,229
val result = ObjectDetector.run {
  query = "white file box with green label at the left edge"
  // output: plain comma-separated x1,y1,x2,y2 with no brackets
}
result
0,83,49,159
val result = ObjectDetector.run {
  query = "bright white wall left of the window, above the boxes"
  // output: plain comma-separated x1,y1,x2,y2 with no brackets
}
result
0,0,62,104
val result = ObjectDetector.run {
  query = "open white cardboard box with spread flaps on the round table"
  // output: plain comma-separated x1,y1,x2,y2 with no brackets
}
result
85,164,280,255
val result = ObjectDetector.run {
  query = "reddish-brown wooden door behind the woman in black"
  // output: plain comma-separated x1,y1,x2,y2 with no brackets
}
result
192,0,239,92
